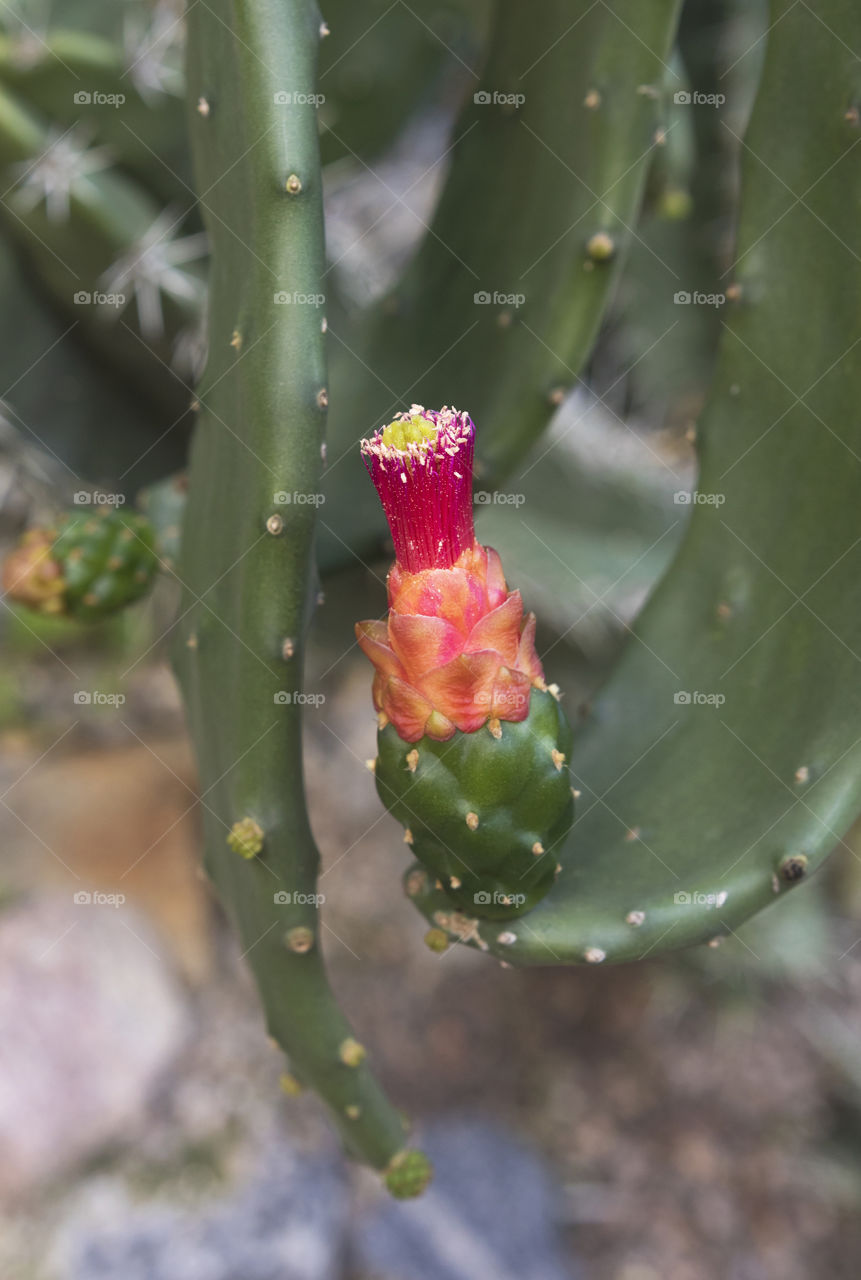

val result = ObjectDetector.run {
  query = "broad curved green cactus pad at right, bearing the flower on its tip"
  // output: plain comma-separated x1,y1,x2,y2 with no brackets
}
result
411,0,861,964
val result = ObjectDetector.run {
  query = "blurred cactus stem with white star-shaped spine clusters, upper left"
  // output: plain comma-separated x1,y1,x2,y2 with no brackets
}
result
0,87,206,421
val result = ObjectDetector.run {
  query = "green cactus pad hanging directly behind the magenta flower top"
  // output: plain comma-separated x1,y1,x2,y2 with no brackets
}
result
321,0,679,564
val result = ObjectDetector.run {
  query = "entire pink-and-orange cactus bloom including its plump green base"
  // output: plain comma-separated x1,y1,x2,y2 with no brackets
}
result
356,404,573,919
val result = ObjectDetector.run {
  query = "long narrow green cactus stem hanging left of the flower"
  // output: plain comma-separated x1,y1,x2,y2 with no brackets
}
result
175,0,403,1170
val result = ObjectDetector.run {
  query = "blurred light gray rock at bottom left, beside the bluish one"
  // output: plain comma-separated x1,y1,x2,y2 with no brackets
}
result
54,1138,348,1280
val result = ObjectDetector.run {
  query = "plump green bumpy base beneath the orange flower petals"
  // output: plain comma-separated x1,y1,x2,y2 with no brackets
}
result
375,689,573,920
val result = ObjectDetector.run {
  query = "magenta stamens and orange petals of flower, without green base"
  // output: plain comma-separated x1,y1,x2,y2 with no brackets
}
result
356,404,546,742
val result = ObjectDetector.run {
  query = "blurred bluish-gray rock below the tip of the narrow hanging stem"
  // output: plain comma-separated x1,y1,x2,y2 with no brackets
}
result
354,1119,574,1280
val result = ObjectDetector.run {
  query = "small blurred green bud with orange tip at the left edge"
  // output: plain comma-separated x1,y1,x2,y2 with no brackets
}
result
3,507,159,622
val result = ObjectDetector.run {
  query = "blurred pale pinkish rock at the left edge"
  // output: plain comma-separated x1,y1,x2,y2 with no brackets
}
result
0,891,187,1198
